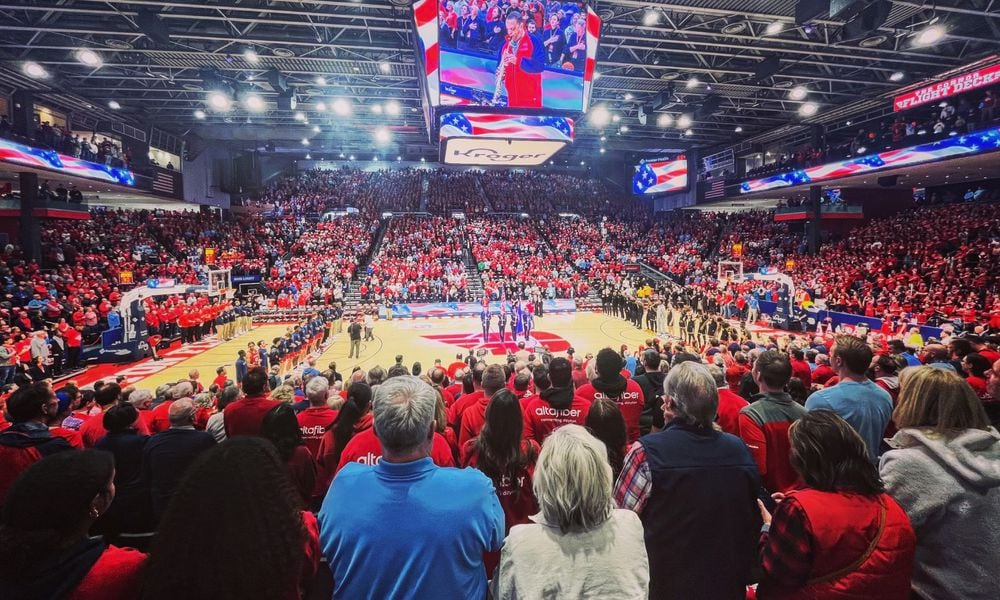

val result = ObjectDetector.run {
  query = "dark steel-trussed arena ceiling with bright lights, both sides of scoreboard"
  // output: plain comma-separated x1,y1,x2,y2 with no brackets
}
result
0,0,1000,154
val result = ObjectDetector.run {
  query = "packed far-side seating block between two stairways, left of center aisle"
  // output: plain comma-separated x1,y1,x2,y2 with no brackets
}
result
360,216,474,302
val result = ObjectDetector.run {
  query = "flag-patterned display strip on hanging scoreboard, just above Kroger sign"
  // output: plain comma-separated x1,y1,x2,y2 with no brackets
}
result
438,112,573,142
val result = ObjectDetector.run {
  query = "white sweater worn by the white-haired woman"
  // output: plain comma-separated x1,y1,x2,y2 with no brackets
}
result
492,509,649,600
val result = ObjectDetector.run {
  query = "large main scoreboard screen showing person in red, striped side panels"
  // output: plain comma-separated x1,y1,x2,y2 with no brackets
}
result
413,0,601,112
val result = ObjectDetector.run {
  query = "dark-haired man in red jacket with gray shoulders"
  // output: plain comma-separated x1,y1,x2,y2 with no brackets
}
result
739,350,806,492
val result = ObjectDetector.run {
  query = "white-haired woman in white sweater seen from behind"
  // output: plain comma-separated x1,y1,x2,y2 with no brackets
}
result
493,425,649,600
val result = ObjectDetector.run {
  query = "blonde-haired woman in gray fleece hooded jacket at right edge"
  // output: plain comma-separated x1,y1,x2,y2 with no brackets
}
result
879,366,1000,600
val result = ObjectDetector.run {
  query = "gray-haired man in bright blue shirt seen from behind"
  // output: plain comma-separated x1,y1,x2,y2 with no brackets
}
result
319,375,504,598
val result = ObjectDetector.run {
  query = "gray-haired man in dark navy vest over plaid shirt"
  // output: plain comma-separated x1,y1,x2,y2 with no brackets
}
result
615,361,761,600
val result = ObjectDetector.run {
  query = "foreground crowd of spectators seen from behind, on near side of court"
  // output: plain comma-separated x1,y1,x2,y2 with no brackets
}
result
0,324,1000,600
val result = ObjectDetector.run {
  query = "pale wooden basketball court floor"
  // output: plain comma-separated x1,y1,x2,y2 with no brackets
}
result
117,312,653,389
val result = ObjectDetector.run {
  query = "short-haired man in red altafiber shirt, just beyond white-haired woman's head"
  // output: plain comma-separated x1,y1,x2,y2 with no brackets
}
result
524,357,588,445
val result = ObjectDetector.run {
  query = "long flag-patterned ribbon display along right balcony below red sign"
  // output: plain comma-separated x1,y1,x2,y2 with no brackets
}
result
740,128,1000,194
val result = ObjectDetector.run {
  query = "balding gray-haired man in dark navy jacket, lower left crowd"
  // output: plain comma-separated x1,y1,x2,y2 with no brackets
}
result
142,398,215,521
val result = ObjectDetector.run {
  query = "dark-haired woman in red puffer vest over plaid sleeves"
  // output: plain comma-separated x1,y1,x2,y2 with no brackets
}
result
757,410,917,600
